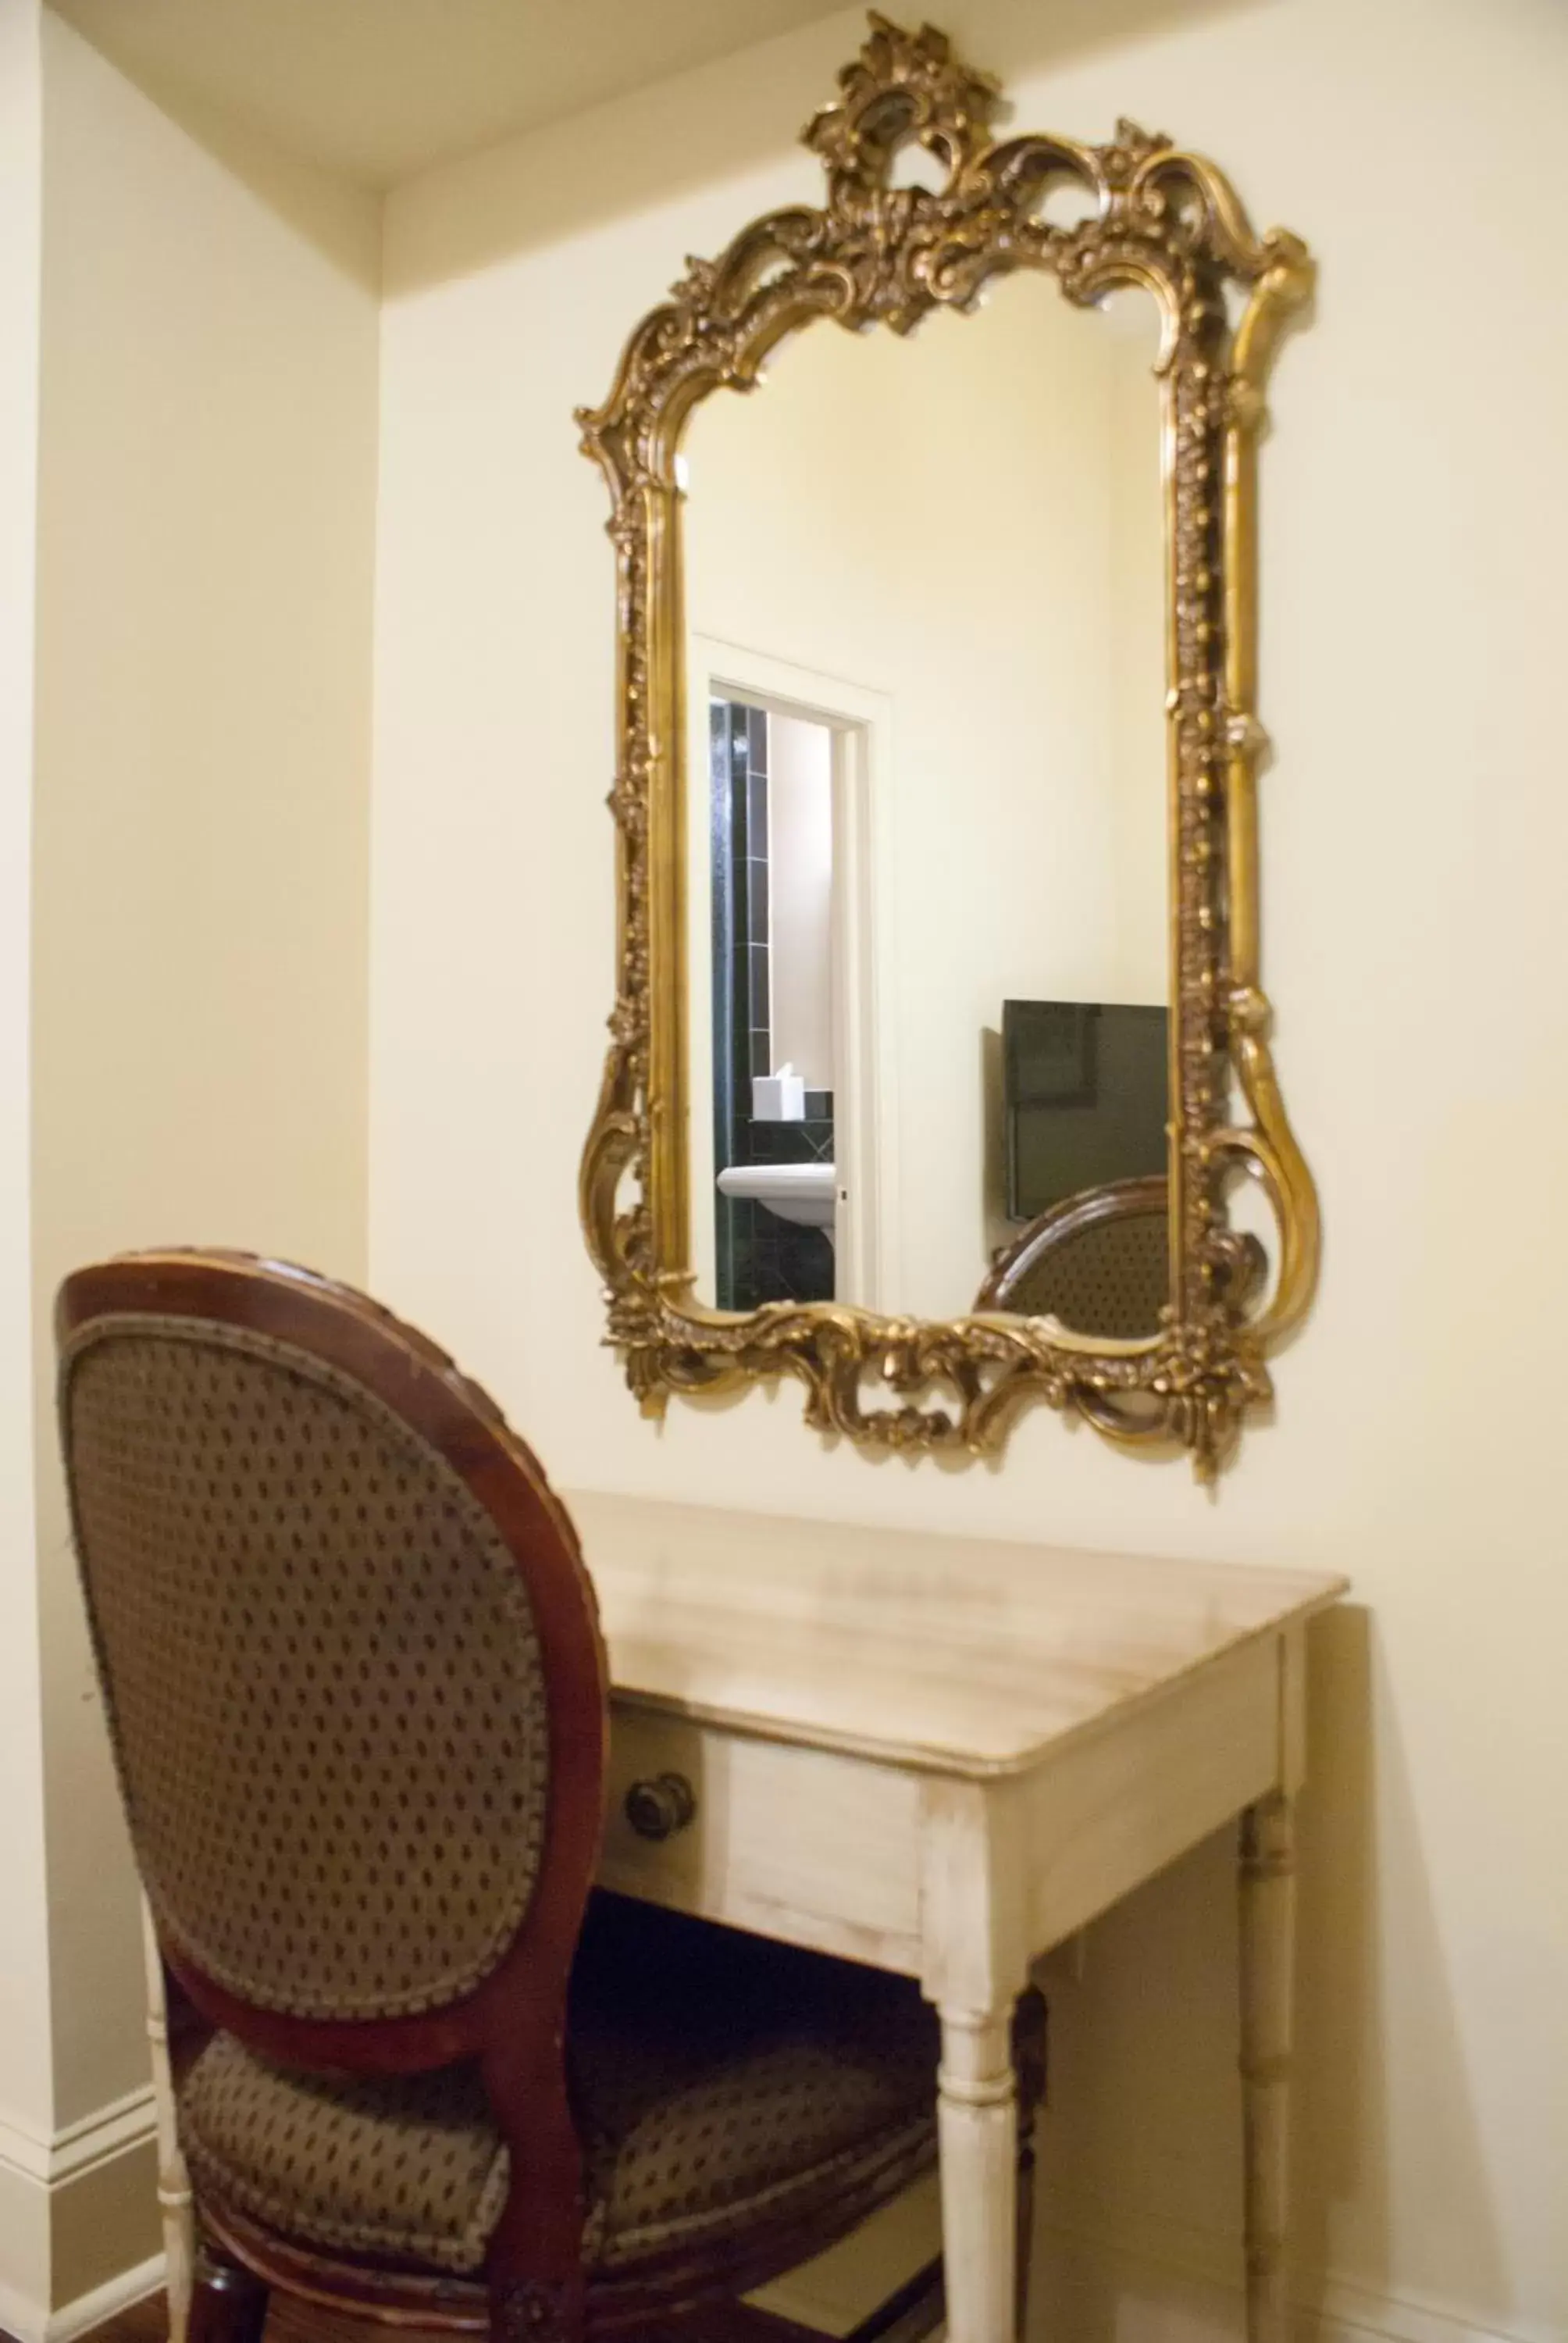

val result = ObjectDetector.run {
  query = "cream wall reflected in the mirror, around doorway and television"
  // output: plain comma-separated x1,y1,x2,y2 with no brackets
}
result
684,276,1165,1317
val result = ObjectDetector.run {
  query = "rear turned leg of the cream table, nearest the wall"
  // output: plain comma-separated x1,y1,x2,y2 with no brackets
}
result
1240,1795,1296,2343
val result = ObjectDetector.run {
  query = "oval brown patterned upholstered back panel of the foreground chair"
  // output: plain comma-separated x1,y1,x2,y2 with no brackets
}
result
61,1314,548,2017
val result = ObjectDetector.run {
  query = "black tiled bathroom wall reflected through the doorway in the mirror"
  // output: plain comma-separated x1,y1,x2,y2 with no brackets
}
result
707,701,832,1310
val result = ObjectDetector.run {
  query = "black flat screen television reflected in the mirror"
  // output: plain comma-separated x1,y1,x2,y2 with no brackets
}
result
1001,1000,1170,1221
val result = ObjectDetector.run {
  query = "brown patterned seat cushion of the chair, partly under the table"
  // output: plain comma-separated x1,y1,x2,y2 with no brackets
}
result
180,1895,938,2273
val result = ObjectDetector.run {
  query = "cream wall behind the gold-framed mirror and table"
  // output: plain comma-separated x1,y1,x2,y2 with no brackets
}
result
370,0,1568,2343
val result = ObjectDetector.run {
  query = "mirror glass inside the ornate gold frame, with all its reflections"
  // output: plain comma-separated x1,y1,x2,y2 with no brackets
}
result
682,274,1170,1340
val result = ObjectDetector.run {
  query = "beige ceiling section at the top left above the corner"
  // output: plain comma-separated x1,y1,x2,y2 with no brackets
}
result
52,0,848,187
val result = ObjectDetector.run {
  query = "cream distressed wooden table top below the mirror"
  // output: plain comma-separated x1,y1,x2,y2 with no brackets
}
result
562,1490,1345,1776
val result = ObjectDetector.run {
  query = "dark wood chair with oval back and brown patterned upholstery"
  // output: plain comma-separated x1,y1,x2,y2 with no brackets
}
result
59,1254,1032,2343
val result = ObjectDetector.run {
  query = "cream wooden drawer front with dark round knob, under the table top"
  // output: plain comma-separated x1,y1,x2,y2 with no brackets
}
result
600,1706,919,1973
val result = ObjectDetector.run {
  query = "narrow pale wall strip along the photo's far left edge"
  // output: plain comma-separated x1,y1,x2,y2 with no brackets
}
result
0,0,54,2327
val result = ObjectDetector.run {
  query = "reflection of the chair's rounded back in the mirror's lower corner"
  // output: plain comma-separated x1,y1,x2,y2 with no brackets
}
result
975,1174,1170,1340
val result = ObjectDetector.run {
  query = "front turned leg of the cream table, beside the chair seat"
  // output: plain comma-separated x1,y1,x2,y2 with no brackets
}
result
938,2008,1017,2343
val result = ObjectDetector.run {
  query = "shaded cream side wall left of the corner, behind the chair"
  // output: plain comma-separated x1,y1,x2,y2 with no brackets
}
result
29,0,380,2268
